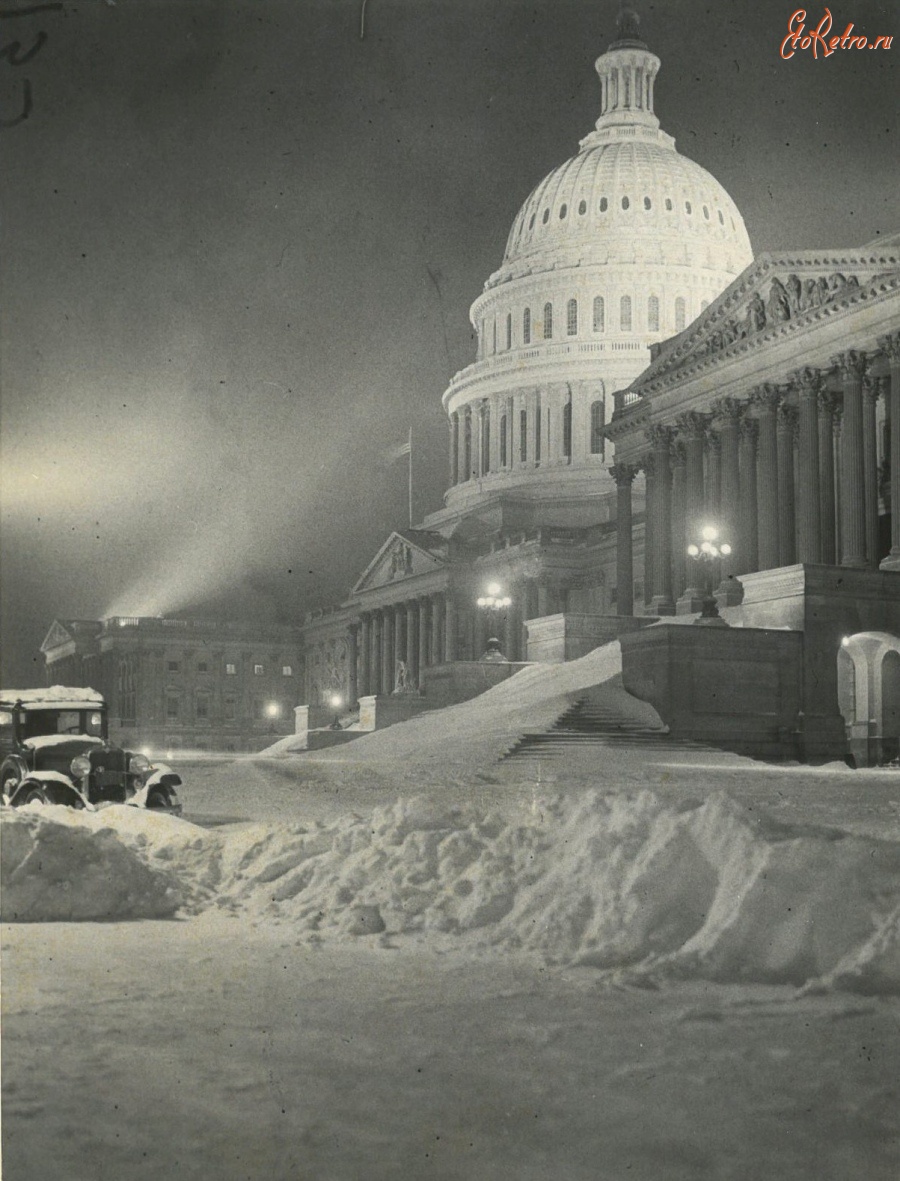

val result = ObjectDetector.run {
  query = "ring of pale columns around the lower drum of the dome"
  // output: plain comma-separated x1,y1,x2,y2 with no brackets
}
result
450,384,578,485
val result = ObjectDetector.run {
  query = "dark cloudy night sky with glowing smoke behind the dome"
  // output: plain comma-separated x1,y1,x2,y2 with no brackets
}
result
0,0,900,685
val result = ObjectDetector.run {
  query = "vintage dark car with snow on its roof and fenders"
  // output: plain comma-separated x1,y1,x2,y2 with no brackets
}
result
0,685,181,816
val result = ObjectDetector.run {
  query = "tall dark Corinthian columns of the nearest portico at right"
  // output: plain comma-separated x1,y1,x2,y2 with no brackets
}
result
609,333,900,614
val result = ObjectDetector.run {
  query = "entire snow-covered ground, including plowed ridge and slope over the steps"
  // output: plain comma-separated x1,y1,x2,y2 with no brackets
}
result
0,645,900,1181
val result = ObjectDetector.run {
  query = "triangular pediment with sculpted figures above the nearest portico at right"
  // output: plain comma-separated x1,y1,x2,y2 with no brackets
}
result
630,244,900,394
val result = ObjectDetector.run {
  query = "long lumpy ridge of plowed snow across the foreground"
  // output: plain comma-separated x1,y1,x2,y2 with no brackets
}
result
2,791,900,992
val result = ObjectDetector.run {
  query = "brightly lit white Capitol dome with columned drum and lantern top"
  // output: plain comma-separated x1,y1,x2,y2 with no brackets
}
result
434,8,752,524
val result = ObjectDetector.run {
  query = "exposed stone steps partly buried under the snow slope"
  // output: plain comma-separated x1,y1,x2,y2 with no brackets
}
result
501,691,713,762
